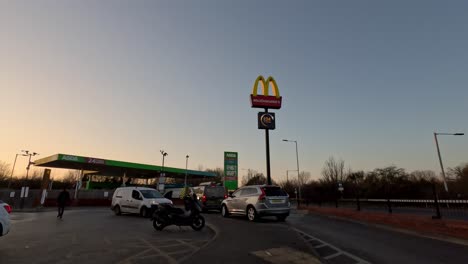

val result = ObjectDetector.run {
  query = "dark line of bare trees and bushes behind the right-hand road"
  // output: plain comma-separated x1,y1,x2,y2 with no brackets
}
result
238,157,468,202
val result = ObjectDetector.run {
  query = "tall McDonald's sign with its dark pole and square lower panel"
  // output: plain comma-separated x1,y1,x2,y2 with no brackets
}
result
250,75,282,185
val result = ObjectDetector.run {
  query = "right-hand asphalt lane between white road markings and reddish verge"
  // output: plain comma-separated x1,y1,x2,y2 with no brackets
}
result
289,212,468,264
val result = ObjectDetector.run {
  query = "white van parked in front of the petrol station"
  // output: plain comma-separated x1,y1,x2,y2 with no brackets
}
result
111,187,172,217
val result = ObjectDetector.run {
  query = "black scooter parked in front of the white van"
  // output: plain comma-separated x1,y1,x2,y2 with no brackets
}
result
151,191,205,231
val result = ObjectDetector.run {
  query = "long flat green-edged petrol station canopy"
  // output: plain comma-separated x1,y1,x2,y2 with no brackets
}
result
34,153,216,179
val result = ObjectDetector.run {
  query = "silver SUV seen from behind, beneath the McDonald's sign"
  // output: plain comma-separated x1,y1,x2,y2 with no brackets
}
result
221,185,291,221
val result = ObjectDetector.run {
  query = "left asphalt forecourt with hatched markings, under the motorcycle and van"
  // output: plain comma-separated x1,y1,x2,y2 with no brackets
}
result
0,209,318,264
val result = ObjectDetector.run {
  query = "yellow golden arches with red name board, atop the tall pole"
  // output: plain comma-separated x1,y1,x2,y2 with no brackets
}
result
250,75,281,109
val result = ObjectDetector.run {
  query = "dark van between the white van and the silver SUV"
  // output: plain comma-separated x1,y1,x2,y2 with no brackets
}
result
193,184,228,211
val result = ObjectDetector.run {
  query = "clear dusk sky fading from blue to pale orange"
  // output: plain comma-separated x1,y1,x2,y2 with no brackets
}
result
0,0,468,183
